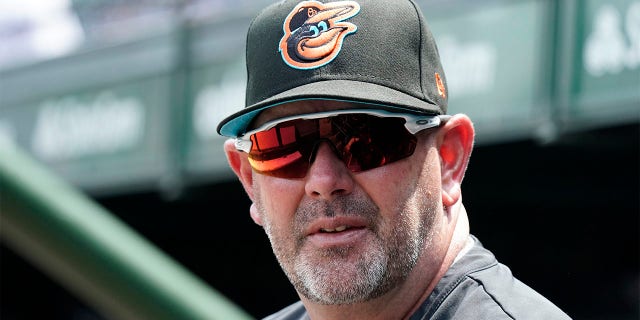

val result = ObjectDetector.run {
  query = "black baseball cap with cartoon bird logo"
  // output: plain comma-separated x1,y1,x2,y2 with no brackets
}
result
217,0,448,137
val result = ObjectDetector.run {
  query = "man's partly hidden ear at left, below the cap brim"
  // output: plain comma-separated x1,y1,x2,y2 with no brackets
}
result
224,139,262,225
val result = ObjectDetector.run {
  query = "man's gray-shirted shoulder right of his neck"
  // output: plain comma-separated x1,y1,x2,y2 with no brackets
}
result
412,238,570,320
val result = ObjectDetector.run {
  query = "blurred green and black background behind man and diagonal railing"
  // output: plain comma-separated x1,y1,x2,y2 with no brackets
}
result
0,0,640,320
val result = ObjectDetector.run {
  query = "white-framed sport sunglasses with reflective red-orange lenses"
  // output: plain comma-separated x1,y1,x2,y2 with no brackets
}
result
235,109,450,179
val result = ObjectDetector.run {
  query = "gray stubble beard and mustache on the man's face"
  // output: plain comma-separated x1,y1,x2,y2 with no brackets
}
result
259,190,435,305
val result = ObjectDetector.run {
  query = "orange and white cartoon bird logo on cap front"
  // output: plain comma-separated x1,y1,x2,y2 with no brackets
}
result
279,1,360,69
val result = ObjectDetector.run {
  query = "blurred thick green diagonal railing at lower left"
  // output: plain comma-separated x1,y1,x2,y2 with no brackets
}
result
0,145,251,320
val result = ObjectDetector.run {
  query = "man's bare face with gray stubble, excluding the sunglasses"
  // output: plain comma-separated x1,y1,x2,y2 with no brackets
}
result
248,101,444,304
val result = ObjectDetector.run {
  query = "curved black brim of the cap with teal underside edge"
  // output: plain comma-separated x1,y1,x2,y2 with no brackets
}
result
217,80,440,137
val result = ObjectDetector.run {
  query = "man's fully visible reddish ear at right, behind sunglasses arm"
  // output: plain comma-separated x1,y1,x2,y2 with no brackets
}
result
438,114,475,207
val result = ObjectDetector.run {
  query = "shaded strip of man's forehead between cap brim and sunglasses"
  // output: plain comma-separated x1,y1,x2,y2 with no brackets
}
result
251,100,356,128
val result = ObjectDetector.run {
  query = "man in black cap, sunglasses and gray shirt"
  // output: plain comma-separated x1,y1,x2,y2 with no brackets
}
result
218,0,569,319
